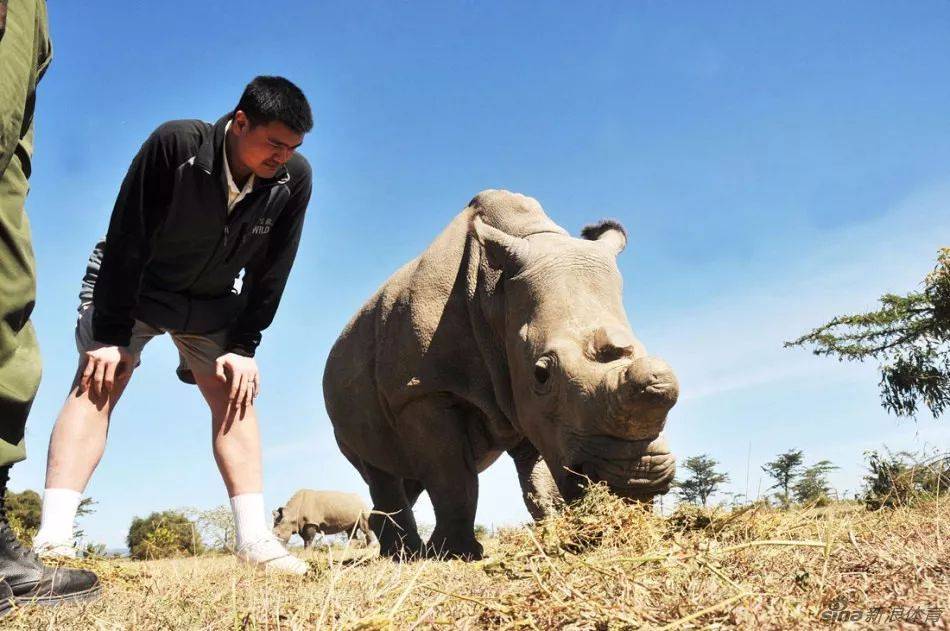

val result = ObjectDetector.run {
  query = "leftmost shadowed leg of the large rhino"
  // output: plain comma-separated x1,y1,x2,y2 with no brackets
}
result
363,463,422,559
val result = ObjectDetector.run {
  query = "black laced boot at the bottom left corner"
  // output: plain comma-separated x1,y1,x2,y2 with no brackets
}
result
0,466,102,615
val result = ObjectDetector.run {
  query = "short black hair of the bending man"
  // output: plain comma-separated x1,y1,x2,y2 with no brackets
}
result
232,76,313,134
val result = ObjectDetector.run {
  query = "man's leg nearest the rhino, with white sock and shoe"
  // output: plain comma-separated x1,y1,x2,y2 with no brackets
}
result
194,373,307,575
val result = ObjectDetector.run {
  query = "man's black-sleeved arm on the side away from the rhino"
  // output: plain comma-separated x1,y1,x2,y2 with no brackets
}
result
93,127,175,346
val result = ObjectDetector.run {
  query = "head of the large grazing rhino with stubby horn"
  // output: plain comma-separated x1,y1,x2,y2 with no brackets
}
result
473,194,679,499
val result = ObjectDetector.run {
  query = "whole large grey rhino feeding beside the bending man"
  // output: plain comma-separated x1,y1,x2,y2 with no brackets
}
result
323,190,679,559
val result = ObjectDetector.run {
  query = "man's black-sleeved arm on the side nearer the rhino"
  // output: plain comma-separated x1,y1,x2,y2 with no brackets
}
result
227,173,311,357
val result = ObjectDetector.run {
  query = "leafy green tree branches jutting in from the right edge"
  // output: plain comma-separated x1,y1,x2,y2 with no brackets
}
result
785,248,950,417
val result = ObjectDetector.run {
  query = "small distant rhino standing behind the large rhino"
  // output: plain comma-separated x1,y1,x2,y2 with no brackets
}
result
273,489,376,548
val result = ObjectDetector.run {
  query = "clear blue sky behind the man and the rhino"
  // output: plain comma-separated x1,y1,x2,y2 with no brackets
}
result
12,0,950,547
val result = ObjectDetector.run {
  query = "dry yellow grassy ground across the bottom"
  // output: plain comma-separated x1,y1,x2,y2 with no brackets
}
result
3,491,950,630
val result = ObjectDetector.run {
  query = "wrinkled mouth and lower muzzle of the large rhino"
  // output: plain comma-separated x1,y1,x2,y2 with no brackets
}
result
562,436,676,500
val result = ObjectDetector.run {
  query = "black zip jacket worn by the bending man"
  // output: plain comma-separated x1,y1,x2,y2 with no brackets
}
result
93,116,311,357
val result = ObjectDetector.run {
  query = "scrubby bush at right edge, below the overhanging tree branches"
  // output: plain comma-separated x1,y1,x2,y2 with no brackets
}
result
864,449,950,510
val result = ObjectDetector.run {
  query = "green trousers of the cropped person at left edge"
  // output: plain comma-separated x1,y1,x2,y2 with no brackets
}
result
0,0,52,466
